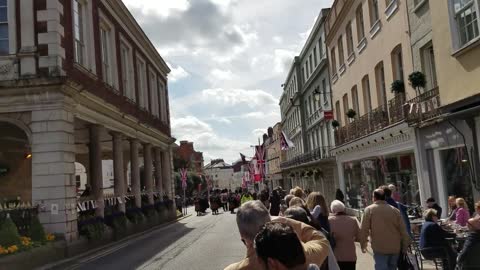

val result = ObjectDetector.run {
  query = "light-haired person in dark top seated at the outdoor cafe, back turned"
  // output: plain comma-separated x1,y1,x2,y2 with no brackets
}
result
419,209,457,270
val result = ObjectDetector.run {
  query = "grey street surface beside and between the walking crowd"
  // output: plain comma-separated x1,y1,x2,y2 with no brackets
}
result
39,208,436,270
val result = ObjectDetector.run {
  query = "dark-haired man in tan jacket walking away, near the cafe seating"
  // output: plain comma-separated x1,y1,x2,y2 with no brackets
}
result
360,188,411,270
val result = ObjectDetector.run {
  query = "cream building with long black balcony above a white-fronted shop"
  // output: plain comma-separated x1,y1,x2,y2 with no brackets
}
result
326,0,422,208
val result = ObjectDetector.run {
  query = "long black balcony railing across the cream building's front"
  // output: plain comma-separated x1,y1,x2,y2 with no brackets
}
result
335,93,405,145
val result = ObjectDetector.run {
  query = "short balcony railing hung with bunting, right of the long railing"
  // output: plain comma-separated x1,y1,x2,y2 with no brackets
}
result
404,87,441,125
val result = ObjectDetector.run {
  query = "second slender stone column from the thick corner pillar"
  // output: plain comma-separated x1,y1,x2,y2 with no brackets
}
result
111,132,125,213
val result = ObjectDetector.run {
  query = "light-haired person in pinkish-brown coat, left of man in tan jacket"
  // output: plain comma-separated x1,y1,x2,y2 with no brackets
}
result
328,200,360,270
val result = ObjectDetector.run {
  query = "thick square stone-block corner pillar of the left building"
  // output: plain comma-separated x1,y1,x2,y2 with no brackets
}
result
31,109,78,242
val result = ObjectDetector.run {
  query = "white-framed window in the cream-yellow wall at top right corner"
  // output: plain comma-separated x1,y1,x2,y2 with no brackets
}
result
452,0,479,47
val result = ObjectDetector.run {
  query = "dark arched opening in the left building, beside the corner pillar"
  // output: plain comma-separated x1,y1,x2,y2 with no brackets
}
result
0,121,32,202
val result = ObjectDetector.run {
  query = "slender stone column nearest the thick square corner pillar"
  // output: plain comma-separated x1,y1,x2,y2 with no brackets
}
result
88,125,104,217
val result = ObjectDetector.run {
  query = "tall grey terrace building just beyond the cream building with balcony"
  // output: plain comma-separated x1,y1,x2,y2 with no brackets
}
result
280,9,338,200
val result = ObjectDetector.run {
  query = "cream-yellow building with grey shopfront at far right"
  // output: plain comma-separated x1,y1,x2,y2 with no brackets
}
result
408,0,480,215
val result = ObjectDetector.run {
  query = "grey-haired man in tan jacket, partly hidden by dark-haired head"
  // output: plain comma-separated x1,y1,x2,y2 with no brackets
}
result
225,201,328,270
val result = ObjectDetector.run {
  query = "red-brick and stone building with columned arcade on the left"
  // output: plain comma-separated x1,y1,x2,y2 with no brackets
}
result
0,0,174,241
